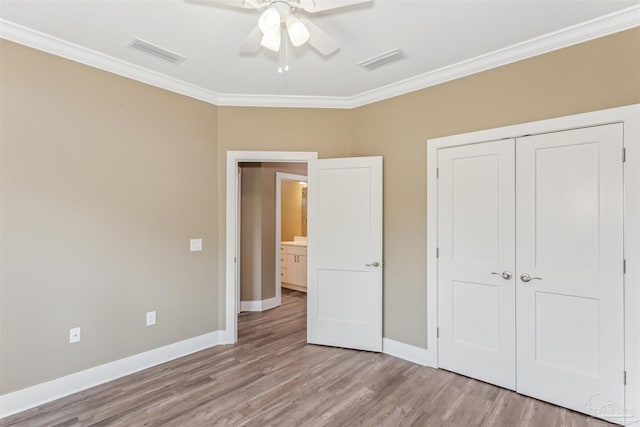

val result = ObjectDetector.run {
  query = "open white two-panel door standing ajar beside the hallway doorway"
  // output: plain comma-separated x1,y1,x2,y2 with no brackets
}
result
307,157,382,351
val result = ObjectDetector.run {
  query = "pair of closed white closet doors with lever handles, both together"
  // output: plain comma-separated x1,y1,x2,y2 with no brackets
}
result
438,124,624,413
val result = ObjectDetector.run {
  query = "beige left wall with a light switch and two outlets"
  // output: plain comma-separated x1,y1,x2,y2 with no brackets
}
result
0,41,219,393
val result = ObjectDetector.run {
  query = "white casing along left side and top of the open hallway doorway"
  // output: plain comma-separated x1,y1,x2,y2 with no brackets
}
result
224,151,318,344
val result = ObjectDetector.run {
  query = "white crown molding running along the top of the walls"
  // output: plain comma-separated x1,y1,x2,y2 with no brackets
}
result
0,5,640,109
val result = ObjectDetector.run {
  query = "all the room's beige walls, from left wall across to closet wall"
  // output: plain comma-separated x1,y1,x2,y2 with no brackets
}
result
0,29,640,393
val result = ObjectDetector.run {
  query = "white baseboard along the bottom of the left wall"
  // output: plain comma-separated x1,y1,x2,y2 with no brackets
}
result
0,331,224,418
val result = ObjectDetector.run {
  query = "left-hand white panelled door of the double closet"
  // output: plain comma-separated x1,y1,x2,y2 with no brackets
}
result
438,139,516,389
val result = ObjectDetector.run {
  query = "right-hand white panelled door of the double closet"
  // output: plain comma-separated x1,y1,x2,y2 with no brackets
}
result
516,124,624,418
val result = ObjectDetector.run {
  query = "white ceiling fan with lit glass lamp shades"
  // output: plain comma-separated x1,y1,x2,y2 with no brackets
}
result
192,0,373,56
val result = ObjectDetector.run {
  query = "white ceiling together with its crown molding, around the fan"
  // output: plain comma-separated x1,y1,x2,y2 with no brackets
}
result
0,0,640,108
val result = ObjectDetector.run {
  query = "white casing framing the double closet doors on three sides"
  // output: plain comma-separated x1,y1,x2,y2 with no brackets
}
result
427,104,640,422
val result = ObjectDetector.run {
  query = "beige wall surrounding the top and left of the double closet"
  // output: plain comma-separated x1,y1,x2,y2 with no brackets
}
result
352,29,640,347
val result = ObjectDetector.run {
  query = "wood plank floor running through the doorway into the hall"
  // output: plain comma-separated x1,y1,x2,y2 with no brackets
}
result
0,290,609,427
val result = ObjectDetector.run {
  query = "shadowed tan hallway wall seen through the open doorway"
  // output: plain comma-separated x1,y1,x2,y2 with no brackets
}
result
240,163,307,301
